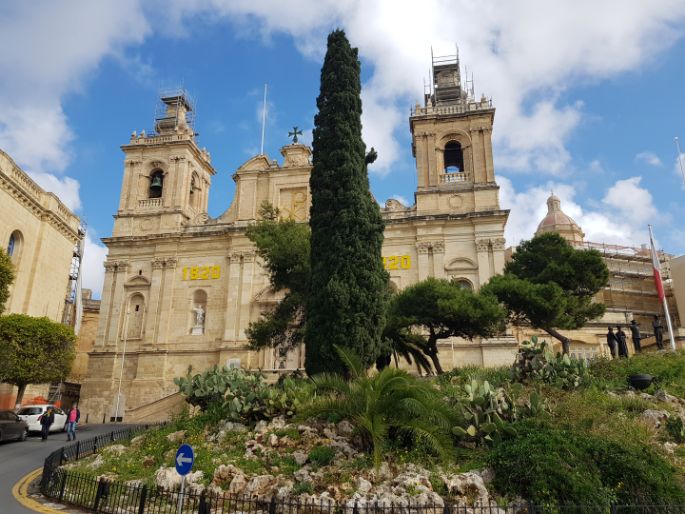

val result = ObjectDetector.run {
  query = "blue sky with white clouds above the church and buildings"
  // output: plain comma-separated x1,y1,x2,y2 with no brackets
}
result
0,0,685,297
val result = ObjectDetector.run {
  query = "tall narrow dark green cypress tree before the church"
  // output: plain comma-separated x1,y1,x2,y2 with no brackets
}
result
305,30,388,375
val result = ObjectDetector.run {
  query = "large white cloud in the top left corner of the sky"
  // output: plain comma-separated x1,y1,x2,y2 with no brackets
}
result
0,0,148,208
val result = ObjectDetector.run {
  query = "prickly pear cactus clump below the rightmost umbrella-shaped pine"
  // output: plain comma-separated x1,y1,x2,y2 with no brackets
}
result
511,336,590,390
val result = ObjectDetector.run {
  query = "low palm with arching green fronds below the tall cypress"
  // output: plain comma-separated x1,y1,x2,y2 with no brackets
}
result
302,347,453,468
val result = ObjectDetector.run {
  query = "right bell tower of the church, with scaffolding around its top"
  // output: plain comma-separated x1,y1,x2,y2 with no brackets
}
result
409,50,499,214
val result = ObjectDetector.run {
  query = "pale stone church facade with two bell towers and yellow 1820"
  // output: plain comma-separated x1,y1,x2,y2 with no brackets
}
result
81,58,516,421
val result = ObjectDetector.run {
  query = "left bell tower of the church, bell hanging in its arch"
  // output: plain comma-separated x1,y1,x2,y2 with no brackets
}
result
112,90,215,237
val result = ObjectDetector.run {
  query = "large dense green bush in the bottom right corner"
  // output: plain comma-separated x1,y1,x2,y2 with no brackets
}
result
488,420,685,512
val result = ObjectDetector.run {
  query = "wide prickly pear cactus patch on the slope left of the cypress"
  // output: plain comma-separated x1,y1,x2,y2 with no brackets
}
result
174,366,308,422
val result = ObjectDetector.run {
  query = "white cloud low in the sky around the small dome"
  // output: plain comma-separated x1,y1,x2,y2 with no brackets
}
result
498,173,667,246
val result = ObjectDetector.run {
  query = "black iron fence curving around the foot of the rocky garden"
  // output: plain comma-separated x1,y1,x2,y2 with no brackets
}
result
40,425,685,514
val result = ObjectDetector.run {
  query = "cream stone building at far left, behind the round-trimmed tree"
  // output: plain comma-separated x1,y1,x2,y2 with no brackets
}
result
0,150,85,408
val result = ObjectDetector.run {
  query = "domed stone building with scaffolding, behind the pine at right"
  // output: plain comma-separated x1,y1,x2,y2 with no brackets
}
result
517,194,685,358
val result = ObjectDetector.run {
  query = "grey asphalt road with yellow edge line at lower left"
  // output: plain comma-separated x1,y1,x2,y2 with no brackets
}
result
0,424,120,514
